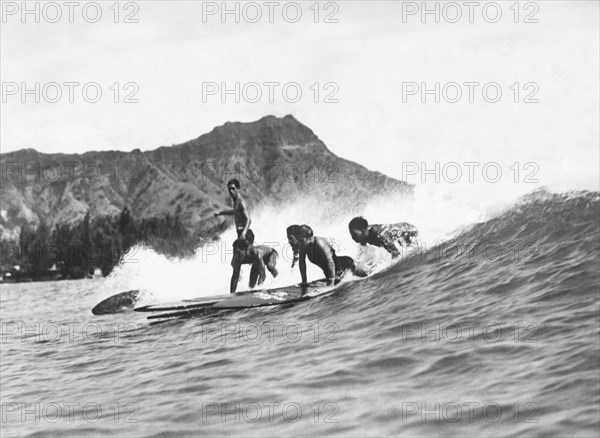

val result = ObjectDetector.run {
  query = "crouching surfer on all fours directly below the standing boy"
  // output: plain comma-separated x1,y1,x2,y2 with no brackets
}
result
229,238,277,294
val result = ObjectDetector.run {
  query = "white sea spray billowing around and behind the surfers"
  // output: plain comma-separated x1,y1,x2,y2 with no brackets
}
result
94,187,494,302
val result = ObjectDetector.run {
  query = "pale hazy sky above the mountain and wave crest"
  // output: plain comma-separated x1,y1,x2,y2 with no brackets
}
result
1,1,600,201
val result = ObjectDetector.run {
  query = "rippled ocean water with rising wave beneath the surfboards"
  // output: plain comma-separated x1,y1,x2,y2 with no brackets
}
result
0,191,600,437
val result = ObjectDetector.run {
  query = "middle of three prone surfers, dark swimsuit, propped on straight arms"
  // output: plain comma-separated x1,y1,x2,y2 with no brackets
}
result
296,225,366,285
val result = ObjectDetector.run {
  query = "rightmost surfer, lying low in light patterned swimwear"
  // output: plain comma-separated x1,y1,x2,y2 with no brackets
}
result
348,216,419,258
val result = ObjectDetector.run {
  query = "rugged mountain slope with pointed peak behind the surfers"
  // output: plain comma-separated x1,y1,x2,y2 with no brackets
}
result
0,115,412,238
